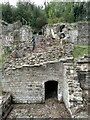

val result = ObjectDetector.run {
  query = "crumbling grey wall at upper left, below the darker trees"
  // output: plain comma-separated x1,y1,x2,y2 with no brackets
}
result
0,21,32,53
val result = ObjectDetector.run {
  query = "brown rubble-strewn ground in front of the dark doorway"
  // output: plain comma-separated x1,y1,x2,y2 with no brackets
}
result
8,99,71,118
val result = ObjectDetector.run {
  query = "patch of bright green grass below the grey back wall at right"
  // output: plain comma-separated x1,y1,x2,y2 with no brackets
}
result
72,46,90,58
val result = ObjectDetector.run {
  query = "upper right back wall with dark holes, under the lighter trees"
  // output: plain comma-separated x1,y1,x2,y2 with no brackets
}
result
43,22,90,46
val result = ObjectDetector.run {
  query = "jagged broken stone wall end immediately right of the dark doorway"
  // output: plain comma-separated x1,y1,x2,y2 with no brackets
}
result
63,63,84,118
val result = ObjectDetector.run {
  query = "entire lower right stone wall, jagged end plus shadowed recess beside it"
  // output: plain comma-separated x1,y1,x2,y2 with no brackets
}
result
63,55,90,118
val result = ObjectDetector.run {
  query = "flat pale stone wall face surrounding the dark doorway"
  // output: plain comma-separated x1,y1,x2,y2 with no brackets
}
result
3,62,63,103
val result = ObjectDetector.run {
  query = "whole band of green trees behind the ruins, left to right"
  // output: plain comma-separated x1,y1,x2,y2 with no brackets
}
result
0,1,90,30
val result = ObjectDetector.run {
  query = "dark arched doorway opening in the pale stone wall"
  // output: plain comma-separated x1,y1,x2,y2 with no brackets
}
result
45,81,58,99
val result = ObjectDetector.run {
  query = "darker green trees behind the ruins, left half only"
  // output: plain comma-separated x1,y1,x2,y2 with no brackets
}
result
2,2,47,30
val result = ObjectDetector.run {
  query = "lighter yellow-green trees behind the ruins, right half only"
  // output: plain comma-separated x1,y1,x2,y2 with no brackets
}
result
45,2,90,23
